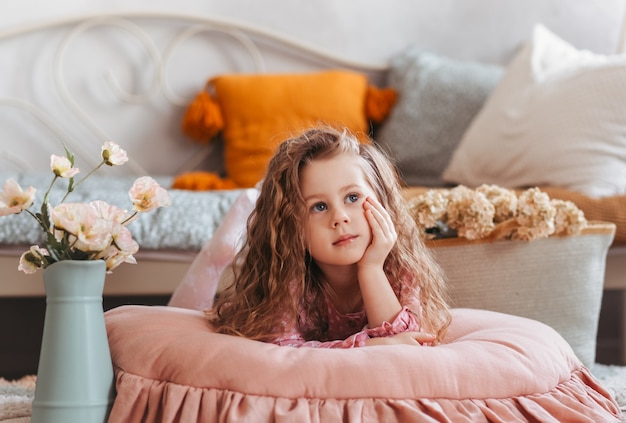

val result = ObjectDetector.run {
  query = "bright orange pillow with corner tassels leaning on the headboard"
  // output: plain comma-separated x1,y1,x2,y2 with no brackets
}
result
179,70,395,189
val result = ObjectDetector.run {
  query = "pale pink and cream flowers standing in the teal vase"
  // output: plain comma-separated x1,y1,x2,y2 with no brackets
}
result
0,142,171,273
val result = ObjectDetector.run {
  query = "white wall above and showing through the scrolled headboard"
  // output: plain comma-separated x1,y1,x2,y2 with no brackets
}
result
0,0,626,174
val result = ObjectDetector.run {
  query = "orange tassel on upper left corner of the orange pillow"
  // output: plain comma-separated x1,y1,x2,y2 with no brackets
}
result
182,91,224,144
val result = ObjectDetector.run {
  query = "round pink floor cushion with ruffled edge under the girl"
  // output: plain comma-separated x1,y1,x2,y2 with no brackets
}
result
106,306,620,422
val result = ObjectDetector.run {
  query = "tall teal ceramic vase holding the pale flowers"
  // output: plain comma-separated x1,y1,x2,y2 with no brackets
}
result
31,260,115,423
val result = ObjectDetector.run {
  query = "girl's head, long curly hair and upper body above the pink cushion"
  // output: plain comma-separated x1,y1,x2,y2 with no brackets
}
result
207,128,450,348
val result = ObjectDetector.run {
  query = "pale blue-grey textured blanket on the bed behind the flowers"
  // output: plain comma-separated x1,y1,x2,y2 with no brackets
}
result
0,172,241,251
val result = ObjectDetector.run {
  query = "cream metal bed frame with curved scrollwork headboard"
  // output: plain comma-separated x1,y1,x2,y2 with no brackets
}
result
0,12,386,297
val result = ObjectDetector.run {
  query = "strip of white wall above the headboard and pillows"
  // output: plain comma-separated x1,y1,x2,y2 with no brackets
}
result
0,0,625,63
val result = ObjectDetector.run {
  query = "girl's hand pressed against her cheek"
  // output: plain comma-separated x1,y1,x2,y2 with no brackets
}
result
358,197,398,268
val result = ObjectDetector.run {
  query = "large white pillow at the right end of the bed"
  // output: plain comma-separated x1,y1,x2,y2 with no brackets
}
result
443,25,626,197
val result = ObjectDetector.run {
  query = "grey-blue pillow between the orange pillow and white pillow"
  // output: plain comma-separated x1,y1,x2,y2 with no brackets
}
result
376,47,504,186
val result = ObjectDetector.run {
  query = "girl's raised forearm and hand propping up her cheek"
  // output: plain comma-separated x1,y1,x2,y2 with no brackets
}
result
358,197,402,327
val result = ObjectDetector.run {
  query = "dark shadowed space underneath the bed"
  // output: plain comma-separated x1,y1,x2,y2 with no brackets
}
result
0,291,626,379
